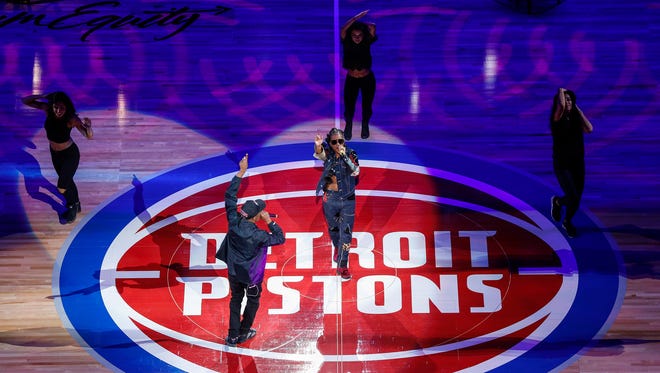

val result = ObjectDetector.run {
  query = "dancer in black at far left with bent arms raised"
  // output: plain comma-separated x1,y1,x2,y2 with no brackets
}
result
23,92,94,223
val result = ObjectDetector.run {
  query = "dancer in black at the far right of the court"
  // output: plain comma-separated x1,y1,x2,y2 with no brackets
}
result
550,88,594,237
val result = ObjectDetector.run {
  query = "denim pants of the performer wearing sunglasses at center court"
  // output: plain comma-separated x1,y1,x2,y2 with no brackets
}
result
323,194,355,268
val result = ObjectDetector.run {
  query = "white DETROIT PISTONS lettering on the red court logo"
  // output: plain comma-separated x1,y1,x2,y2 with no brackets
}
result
171,231,503,315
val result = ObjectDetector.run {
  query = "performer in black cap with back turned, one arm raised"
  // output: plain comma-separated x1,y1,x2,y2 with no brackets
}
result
215,154,285,347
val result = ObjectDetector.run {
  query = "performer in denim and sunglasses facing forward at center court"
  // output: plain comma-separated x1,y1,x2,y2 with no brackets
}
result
314,128,360,281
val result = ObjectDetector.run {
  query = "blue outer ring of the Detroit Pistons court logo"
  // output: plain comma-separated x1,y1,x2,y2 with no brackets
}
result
53,142,625,372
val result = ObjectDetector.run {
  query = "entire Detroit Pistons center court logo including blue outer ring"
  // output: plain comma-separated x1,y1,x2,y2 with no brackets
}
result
53,143,624,372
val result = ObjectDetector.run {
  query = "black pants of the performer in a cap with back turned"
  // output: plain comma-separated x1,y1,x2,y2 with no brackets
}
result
229,277,261,338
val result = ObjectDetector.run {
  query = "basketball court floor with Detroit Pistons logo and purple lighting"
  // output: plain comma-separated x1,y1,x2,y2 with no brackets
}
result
0,0,660,372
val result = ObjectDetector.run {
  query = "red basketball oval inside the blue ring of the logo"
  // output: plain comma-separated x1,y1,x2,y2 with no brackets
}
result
106,166,564,370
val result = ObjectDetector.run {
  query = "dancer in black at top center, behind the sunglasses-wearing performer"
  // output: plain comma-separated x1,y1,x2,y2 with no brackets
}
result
340,10,378,140
